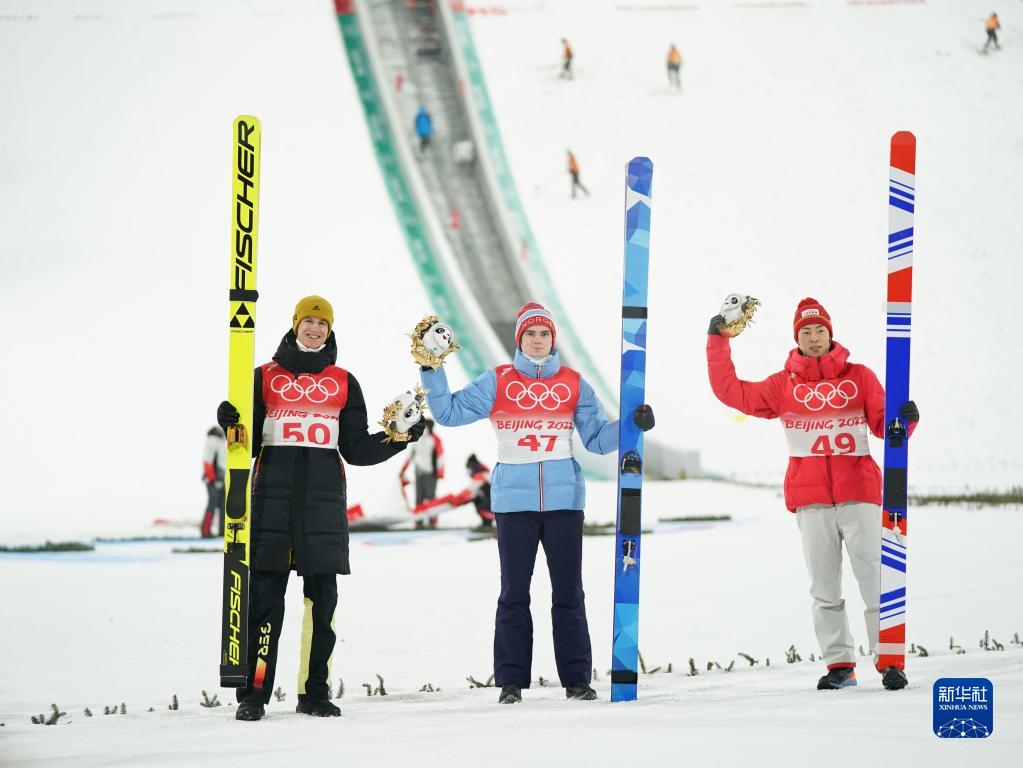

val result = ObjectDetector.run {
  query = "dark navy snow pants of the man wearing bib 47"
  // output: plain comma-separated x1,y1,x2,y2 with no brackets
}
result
494,509,593,688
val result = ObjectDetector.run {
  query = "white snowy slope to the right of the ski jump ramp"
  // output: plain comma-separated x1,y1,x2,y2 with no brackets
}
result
472,0,1023,490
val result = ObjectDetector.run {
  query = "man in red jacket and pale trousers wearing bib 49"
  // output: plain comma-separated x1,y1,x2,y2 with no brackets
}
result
707,299,920,690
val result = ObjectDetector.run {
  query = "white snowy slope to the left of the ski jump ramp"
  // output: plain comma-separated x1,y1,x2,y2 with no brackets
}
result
0,0,492,542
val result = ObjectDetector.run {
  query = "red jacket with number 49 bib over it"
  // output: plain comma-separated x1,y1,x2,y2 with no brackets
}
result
707,334,916,511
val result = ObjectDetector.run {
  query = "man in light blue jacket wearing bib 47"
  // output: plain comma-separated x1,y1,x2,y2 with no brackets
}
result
409,304,654,704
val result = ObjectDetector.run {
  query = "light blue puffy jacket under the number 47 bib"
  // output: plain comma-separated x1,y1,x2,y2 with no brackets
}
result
421,350,618,512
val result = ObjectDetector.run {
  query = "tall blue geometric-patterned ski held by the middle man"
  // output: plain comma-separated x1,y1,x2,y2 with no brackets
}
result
611,157,654,702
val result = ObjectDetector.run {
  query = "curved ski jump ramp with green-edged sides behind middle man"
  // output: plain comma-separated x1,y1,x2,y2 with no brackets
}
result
335,0,700,478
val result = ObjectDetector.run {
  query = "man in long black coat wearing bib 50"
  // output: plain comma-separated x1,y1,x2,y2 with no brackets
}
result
217,297,422,720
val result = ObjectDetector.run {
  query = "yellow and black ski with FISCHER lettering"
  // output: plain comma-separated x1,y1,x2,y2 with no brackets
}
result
220,116,262,688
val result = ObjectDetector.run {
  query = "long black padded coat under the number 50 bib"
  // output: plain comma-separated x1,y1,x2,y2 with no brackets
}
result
250,330,406,574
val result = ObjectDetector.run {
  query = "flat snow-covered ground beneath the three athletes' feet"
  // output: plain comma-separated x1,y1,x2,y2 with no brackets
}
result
0,482,1023,767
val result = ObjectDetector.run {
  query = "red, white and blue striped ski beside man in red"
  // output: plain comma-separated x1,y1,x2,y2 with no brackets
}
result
878,131,917,687
